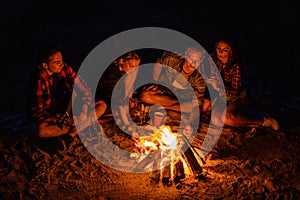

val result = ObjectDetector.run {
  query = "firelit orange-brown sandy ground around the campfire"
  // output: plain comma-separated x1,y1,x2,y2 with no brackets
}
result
0,86,300,199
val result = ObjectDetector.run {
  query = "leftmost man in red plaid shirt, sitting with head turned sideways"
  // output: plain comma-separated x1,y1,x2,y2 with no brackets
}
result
31,44,106,137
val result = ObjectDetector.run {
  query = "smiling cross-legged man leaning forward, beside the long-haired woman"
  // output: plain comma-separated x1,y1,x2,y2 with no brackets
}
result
141,47,219,129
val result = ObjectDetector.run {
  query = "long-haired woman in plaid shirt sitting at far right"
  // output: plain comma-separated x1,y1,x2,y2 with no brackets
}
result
203,37,279,130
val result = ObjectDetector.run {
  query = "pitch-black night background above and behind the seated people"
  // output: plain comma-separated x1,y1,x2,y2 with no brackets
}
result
0,0,300,115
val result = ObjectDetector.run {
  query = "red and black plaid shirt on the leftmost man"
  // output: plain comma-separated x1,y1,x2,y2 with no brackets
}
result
31,63,92,121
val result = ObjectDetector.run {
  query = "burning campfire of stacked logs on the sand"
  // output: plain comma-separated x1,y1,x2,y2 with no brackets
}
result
136,125,204,184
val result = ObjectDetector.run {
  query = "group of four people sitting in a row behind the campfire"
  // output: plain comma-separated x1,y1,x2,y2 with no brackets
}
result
31,37,279,137
